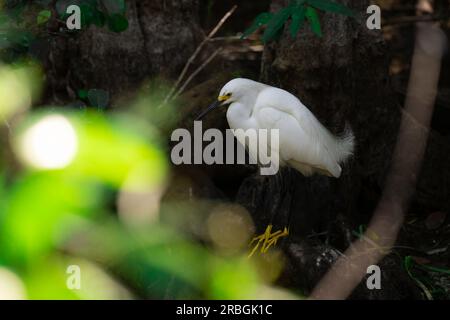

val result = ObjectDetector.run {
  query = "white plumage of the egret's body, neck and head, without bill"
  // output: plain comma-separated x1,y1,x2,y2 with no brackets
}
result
209,78,354,178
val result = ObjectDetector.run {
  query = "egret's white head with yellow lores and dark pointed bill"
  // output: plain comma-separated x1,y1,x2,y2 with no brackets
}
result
197,78,264,120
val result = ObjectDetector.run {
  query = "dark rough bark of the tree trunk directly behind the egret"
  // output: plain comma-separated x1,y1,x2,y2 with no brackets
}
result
240,0,400,235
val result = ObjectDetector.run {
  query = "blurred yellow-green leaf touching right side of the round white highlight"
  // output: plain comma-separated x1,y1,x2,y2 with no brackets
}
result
68,114,167,187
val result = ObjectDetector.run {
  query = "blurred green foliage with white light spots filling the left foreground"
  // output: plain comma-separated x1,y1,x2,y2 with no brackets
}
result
0,0,298,299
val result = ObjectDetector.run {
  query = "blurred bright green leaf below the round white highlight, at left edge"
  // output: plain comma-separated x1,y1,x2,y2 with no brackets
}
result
1,172,102,262
